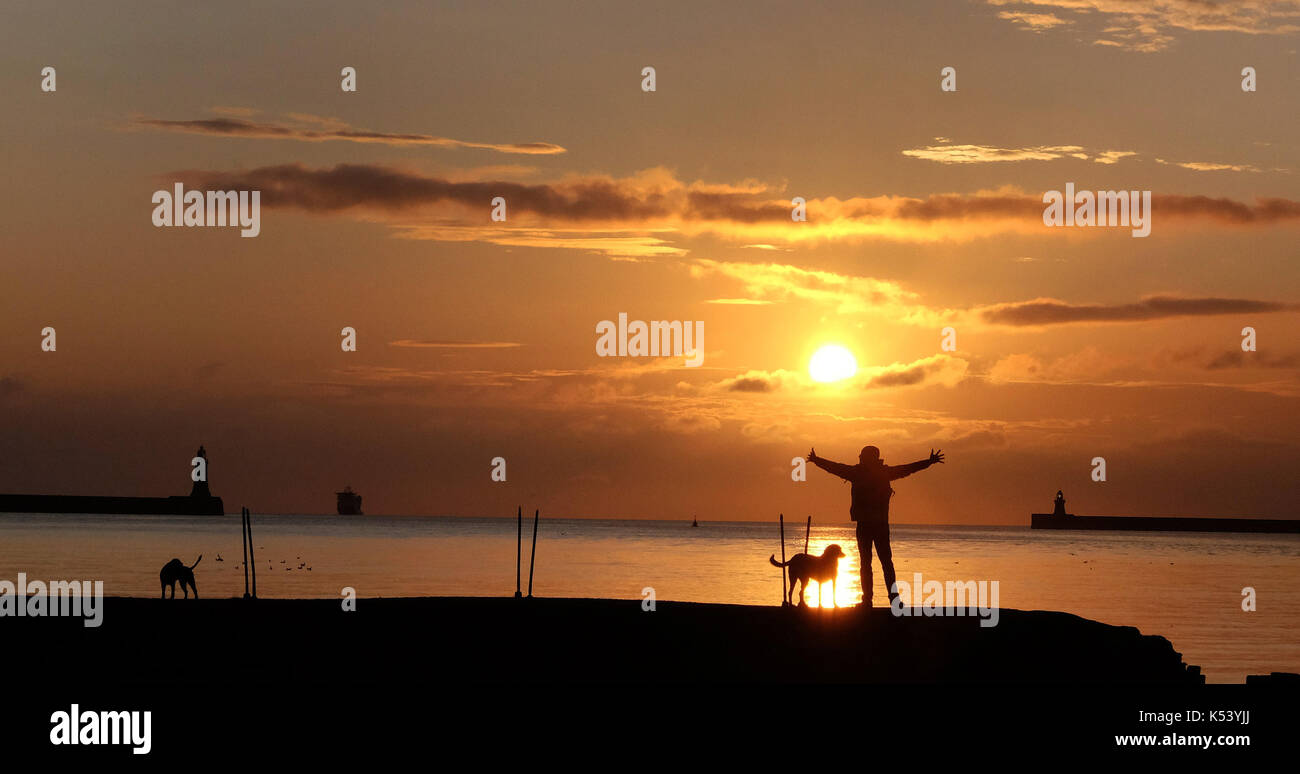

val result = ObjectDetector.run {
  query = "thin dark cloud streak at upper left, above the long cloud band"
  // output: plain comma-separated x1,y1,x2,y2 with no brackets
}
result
135,115,566,156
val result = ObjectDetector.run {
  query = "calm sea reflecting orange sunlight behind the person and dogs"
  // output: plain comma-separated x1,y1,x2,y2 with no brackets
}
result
0,514,1300,682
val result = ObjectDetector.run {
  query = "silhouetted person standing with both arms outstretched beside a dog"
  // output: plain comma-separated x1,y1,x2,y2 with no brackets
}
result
807,446,944,607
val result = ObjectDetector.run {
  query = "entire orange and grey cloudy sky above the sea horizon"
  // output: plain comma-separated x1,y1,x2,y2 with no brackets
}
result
0,0,1300,524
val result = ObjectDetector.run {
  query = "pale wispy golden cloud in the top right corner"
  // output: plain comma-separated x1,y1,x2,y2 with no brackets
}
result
987,0,1300,52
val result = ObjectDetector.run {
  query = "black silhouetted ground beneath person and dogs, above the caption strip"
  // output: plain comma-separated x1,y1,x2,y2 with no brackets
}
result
12,597,1204,686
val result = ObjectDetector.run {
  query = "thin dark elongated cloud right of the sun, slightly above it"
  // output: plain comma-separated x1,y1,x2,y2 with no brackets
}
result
976,295,1300,327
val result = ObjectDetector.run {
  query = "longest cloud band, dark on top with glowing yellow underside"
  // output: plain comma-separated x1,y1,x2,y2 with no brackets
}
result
172,164,1300,258
